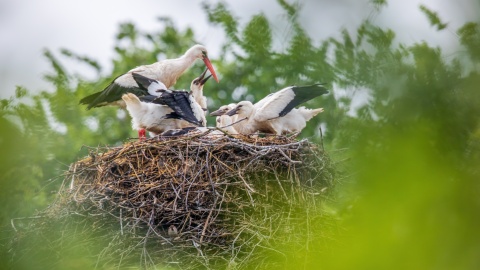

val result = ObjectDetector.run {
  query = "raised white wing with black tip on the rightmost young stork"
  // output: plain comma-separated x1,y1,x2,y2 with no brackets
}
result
254,84,328,121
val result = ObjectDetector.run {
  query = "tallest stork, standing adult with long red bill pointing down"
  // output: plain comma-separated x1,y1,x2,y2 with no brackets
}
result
80,44,218,109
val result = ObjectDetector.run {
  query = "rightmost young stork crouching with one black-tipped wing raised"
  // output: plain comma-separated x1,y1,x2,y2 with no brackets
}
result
226,84,328,135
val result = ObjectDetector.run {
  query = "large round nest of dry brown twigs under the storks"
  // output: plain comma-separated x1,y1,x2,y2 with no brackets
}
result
14,134,334,268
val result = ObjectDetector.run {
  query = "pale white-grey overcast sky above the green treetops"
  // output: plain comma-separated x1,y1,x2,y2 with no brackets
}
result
0,0,480,98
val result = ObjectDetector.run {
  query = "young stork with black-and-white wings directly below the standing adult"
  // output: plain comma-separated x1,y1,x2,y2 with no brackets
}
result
122,73,206,138
